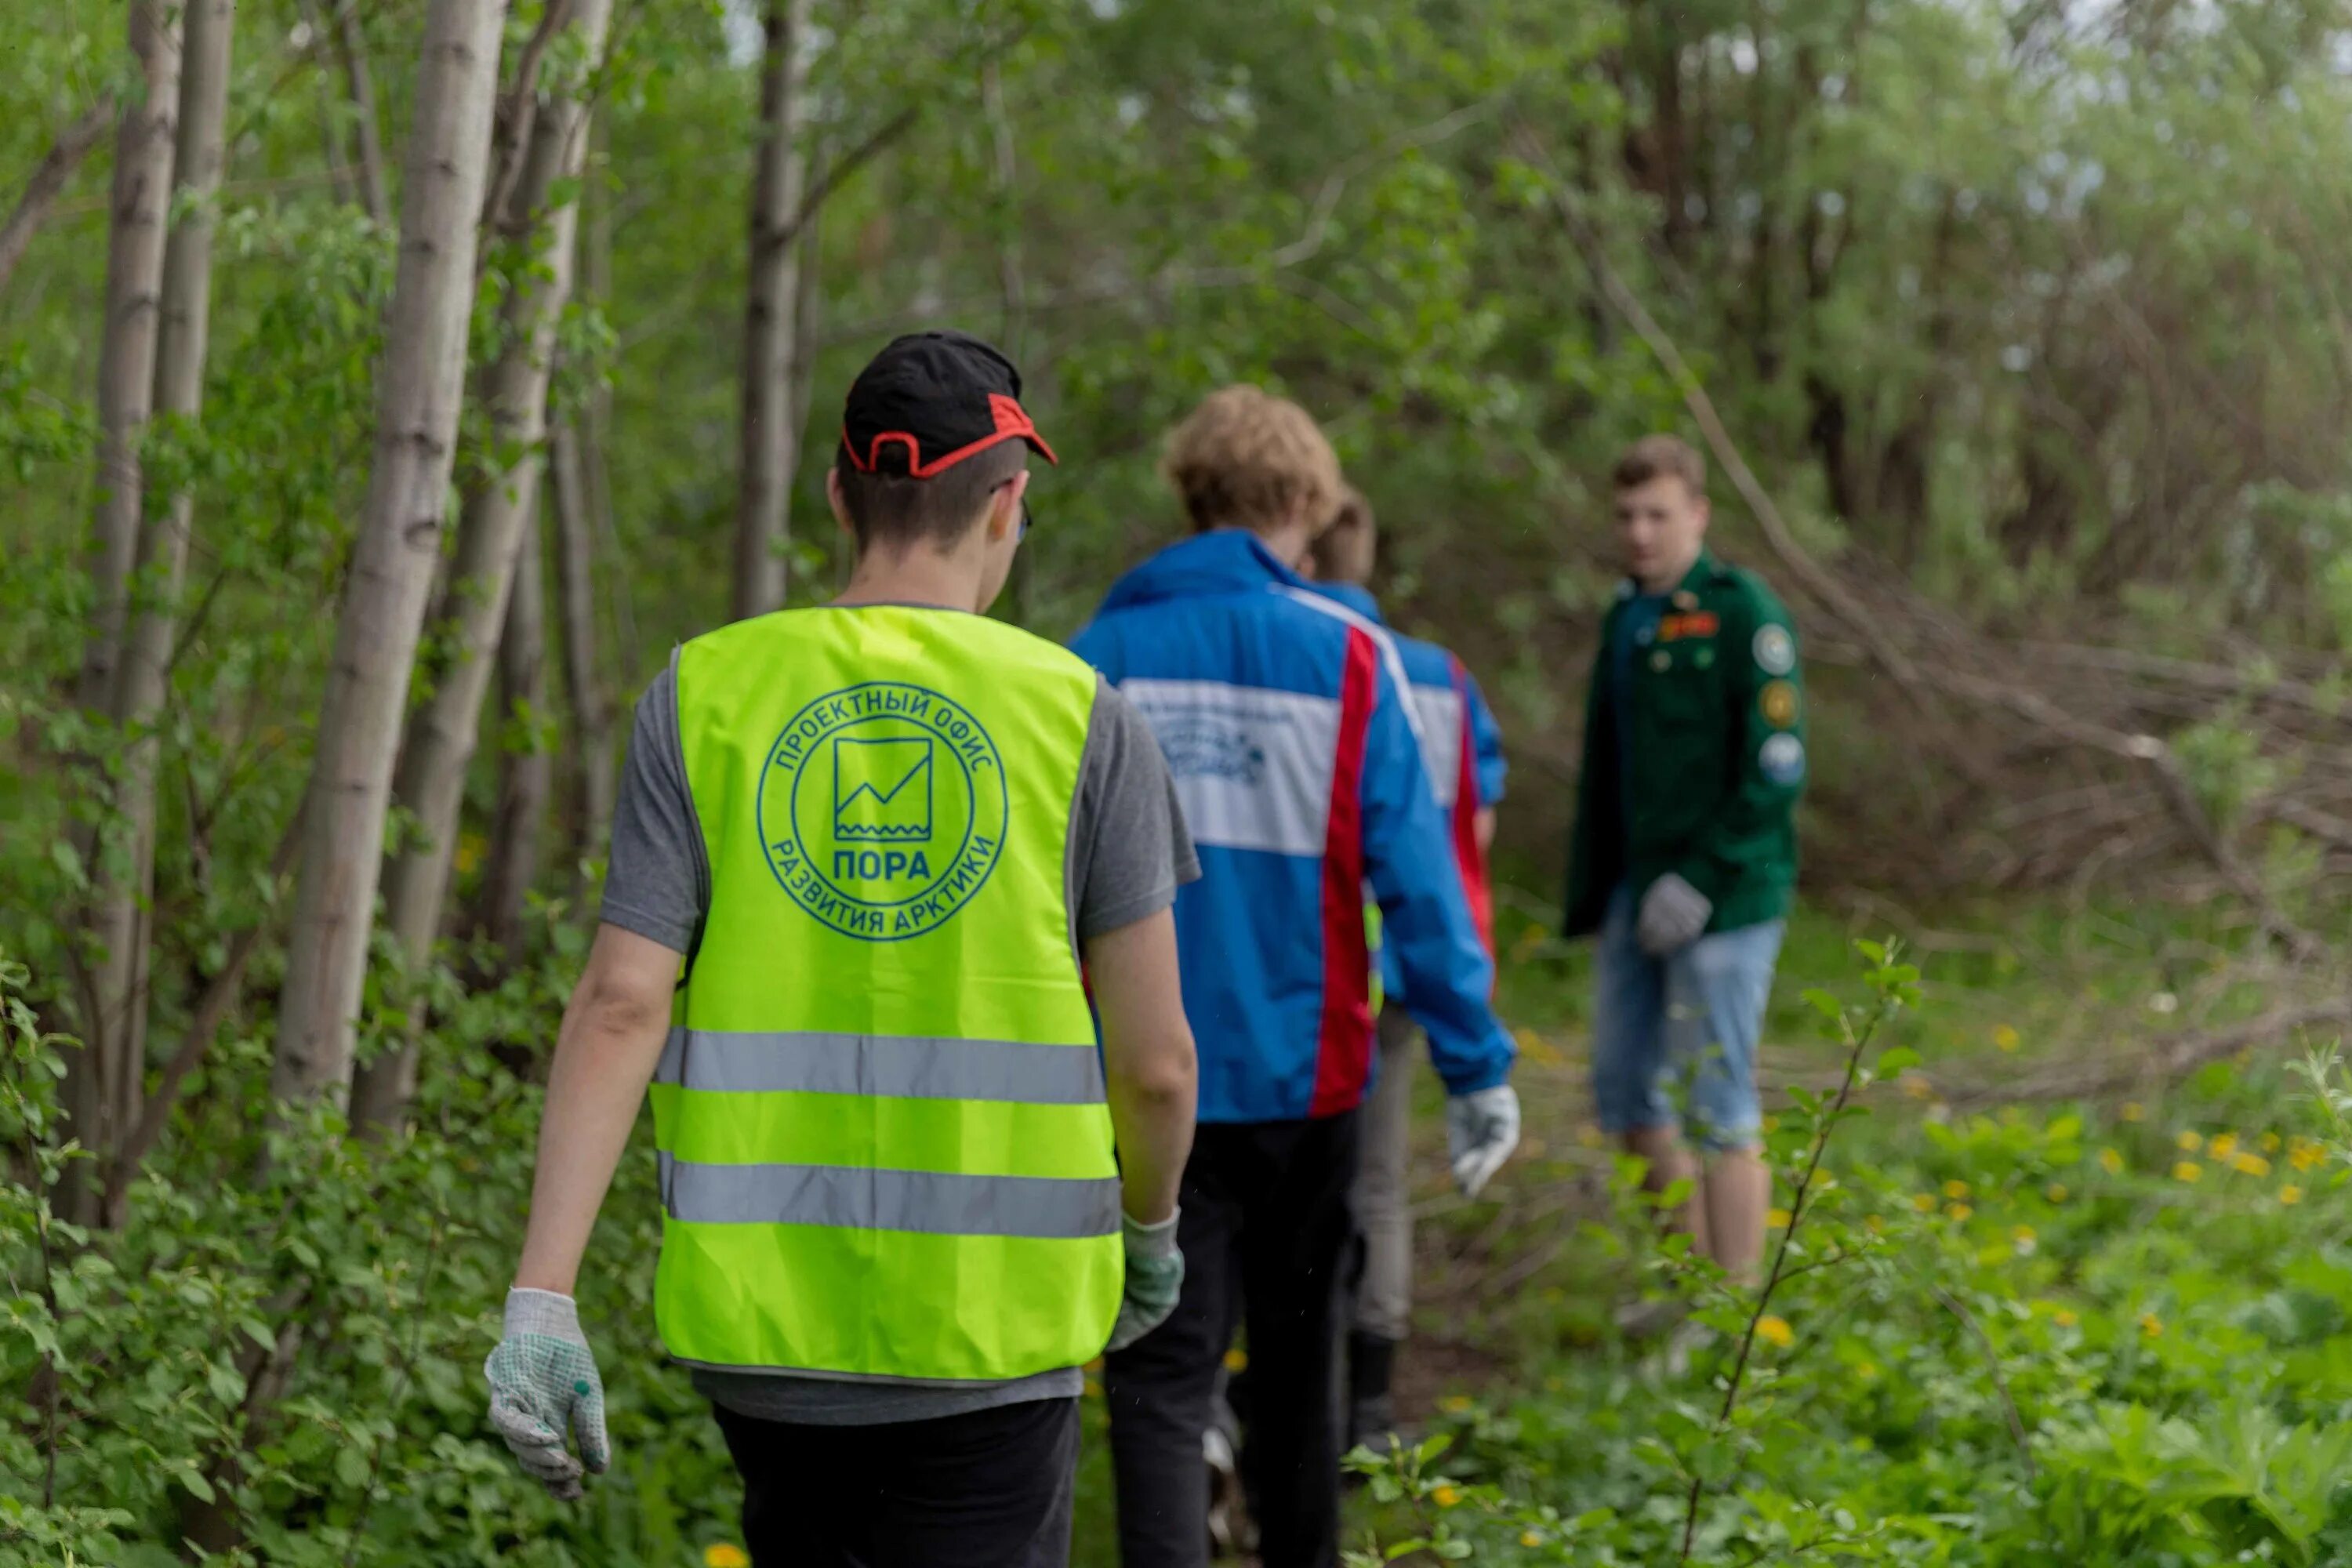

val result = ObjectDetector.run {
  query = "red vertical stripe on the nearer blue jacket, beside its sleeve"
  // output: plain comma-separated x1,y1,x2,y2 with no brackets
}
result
1308,628,1381,1116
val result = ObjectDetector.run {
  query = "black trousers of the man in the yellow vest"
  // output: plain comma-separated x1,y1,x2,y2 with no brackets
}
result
713,1399,1077,1568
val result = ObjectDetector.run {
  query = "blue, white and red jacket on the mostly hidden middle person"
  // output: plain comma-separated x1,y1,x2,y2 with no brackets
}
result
1312,583,1510,1011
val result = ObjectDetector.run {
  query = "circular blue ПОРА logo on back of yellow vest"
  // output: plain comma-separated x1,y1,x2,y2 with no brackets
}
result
755,682,1007,942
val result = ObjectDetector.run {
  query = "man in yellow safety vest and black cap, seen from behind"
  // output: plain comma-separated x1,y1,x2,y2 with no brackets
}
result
487,332,1200,1568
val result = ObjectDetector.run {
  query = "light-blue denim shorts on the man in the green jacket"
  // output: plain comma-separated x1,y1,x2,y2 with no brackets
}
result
1592,886,1785,1149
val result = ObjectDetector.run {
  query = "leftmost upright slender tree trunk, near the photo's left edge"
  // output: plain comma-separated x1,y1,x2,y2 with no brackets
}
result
64,0,179,1220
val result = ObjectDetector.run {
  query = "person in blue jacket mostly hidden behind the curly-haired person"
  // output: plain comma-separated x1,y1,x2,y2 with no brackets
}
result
1308,489,1508,1446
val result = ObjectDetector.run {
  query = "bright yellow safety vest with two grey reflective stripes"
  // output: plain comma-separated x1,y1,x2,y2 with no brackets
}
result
652,607,1122,1382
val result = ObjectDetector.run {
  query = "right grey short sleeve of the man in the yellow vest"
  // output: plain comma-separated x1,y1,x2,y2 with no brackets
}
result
1068,682,1200,942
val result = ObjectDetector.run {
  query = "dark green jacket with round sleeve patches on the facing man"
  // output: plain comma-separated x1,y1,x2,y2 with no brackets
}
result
1566,555,1806,935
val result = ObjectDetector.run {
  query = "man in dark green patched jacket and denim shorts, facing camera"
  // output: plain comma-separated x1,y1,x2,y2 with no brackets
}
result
1566,435,1809,1276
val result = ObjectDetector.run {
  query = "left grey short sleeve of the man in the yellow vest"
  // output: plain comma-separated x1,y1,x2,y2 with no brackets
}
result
600,656,710,952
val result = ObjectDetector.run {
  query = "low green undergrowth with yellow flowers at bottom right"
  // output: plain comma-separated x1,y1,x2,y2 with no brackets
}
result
1350,947,2352,1568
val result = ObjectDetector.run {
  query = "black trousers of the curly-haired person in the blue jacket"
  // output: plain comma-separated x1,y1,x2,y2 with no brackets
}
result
1103,1112,1357,1568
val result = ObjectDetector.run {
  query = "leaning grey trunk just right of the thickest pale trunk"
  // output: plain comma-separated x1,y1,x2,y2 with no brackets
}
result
350,0,612,1128
